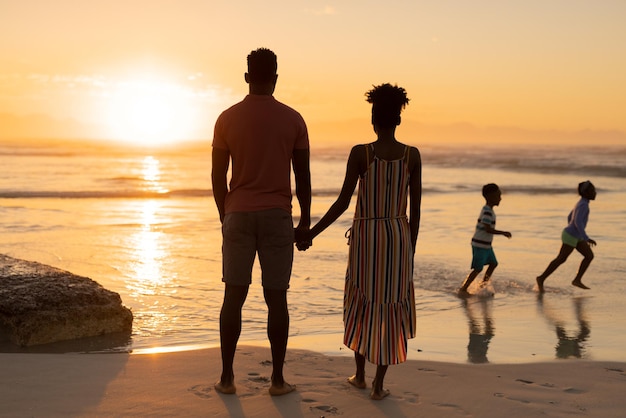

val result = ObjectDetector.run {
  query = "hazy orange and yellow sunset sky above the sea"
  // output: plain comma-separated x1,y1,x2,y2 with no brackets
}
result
0,0,626,144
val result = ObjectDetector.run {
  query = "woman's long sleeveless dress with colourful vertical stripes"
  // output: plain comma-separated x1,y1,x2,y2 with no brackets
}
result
343,146,416,365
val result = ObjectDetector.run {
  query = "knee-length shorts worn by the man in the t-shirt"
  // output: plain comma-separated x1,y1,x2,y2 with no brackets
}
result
222,209,294,290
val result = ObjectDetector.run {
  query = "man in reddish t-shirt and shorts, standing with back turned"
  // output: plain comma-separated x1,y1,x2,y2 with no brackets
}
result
211,48,311,396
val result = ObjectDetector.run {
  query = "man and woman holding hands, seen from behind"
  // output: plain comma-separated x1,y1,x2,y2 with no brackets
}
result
212,48,422,400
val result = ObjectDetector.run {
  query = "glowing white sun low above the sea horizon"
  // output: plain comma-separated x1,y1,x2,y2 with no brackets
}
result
107,76,198,146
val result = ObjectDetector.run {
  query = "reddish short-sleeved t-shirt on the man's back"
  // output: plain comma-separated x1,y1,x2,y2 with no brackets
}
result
213,94,309,213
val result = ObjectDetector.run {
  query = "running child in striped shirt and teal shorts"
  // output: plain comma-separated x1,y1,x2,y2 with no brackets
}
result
459,183,511,297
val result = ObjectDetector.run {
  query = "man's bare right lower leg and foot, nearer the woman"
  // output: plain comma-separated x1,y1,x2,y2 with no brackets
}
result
263,289,295,396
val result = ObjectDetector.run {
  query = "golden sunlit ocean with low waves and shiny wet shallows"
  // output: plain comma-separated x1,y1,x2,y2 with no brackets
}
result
0,140,626,363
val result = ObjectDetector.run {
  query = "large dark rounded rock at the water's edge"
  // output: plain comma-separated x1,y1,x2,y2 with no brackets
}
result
0,254,133,346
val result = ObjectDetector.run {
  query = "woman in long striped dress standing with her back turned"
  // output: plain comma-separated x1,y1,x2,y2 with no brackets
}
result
297,83,422,400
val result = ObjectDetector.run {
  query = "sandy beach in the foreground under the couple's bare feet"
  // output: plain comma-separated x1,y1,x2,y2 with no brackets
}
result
0,346,626,418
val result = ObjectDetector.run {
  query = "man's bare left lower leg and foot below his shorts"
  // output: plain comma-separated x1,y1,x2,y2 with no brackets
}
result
215,284,248,394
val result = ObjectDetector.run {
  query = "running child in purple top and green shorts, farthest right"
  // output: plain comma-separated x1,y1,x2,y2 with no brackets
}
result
537,180,596,293
